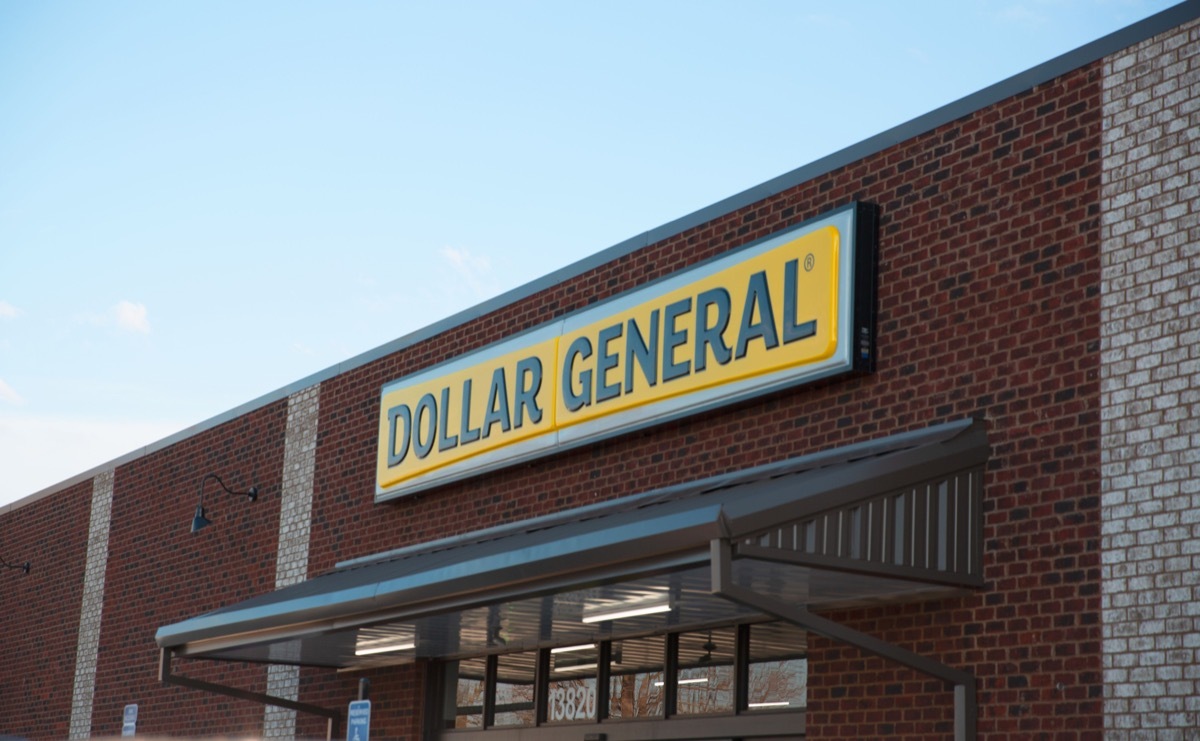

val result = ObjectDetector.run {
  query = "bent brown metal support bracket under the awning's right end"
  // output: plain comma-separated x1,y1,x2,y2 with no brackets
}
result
710,538,978,741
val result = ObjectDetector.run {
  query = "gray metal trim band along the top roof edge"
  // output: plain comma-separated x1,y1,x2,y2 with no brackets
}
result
7,0,1200,514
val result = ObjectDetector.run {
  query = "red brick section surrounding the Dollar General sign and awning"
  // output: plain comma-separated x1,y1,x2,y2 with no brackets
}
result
297,66,1102,739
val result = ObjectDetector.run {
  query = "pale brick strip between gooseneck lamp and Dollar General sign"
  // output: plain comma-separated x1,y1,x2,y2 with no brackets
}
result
263,385,320,739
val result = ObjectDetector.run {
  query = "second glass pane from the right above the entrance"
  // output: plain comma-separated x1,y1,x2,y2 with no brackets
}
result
676,627,737,716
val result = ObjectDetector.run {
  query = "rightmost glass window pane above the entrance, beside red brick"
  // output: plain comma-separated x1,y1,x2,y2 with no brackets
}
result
746,622,809,711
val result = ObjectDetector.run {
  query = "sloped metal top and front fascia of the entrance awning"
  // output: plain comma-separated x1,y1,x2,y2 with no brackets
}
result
155,420,986,647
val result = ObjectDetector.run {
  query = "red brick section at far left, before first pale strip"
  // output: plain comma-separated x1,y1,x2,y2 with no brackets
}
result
0,481,91,739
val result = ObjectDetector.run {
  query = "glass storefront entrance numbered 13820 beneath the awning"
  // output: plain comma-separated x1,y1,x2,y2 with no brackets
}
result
430,622,808,740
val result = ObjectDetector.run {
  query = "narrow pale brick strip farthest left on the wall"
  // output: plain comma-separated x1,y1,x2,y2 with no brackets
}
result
70,471,113,739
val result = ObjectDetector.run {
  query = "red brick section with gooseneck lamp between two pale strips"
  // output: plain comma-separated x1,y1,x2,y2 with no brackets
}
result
92,400,287,736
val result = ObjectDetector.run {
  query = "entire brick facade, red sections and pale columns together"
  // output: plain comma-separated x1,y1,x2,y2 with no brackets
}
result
0,8,1200,740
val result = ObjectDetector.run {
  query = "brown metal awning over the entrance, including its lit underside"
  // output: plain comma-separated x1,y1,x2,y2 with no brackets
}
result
156,420,989,669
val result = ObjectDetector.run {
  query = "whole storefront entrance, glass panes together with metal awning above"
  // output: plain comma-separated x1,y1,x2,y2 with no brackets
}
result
157,420,989,741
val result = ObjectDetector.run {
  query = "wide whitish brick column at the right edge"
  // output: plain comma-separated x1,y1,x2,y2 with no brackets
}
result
1102,15,1200,740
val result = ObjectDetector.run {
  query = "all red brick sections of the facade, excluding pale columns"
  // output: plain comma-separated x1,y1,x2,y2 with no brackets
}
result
0,50,1103,740
